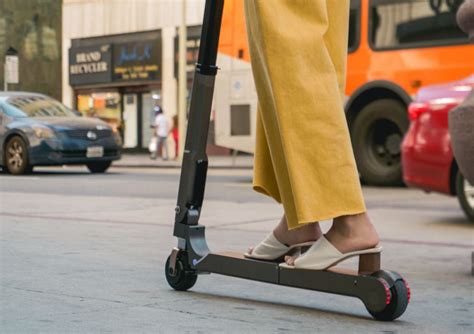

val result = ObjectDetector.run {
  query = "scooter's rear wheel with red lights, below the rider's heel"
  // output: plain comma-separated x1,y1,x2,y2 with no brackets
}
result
367,271,410,321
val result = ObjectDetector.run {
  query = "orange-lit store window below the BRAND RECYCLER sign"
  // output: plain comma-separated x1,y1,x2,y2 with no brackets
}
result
77,92,122,131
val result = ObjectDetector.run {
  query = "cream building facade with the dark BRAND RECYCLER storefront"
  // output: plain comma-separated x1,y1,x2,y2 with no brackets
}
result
62,0,211,150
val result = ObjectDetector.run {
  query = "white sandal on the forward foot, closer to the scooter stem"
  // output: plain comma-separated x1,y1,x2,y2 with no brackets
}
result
244,233,314,261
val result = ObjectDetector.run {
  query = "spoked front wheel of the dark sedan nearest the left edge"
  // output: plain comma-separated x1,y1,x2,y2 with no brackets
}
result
5,136,33,175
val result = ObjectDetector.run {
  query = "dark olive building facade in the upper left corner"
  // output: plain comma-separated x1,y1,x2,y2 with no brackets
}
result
0,0,62,99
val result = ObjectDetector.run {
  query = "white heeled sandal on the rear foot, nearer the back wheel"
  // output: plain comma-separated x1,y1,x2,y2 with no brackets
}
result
280,236,382,270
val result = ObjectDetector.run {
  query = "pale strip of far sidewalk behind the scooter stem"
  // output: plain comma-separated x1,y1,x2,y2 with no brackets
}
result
113,153,253,169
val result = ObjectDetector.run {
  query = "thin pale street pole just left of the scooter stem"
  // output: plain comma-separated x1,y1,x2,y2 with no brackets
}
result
178,0,187,161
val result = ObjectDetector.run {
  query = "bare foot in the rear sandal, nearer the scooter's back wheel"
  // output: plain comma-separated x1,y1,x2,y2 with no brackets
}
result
285,213,379,265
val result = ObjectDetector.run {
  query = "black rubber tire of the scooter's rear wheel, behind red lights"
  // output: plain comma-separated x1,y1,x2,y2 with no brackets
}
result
367,272,410,321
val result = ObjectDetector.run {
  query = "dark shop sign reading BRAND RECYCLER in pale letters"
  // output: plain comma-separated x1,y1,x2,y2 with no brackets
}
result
69,44,112,86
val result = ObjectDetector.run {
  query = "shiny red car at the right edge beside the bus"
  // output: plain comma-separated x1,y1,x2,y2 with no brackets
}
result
402,75,474,221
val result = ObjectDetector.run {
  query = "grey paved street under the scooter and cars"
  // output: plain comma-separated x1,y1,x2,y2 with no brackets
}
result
0,167,474,333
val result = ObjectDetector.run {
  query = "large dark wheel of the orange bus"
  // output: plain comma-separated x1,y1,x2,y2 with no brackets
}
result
351,99,409,186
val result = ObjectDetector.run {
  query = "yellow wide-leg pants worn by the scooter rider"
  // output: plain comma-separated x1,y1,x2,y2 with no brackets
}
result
245,0,366,229
